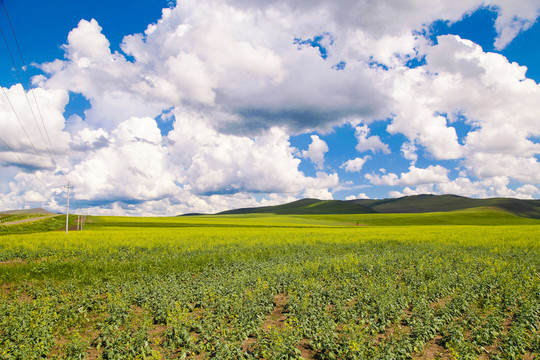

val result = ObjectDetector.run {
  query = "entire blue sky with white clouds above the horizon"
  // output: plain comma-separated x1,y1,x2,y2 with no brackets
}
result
0,0,540,215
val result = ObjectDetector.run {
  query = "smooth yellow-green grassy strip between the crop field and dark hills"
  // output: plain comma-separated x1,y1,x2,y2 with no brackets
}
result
0,208,540,235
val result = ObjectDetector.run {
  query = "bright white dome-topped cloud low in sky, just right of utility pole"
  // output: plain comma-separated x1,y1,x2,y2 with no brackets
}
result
70,118,178,200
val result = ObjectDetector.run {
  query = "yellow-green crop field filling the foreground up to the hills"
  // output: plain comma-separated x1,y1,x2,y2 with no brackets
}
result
0,210,540,359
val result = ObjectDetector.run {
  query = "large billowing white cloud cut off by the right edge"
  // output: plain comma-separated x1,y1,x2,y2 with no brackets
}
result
388,35,540,183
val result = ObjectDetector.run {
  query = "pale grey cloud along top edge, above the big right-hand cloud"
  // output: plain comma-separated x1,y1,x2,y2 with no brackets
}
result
233,0,540,46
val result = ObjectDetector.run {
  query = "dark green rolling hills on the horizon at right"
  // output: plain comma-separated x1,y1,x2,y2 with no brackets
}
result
219,195,540,219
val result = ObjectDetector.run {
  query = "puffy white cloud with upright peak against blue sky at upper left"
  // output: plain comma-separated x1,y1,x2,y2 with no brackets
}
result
39,19,170,131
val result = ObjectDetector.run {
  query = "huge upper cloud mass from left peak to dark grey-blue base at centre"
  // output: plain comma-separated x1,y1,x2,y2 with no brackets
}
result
42,1,386,132
